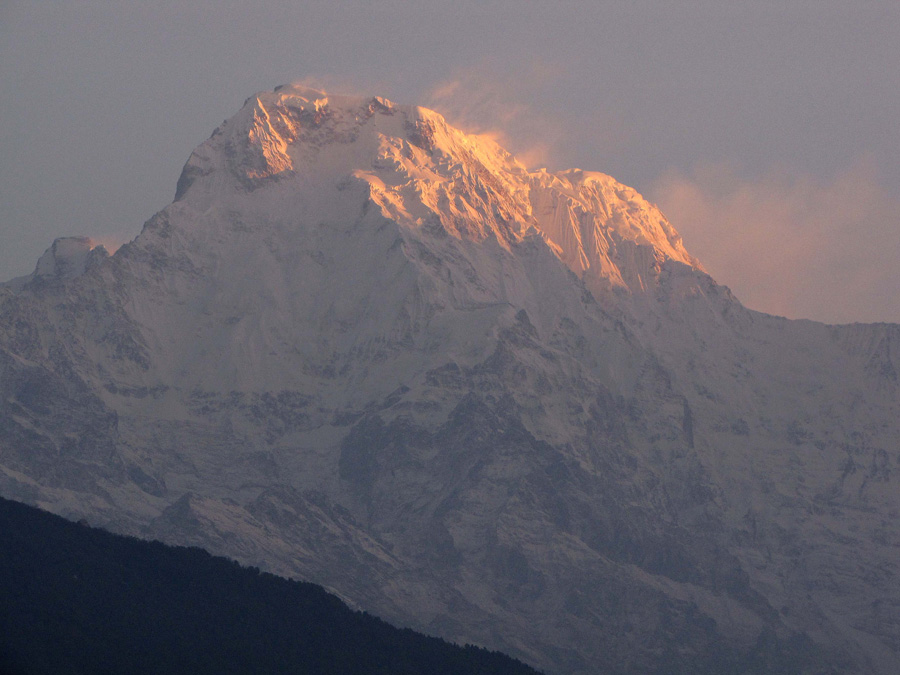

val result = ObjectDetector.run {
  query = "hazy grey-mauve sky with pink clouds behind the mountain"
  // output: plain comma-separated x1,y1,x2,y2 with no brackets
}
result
0,0,900,322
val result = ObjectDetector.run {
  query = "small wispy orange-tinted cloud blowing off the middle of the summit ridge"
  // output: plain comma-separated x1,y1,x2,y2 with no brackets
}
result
424,64,565,168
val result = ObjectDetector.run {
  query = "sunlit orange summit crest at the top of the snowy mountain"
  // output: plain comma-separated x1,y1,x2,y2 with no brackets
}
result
176,84,702,302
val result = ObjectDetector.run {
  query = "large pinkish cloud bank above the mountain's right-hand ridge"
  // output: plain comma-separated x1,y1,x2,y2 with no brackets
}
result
649,161,900,323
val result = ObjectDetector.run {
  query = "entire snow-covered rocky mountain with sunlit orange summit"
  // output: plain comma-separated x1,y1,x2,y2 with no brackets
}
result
0,86,900,673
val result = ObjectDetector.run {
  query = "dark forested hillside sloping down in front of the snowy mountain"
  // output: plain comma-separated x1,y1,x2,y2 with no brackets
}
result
0,499,536,675
